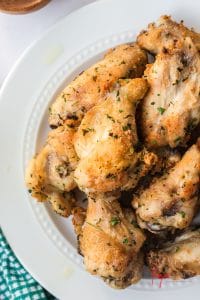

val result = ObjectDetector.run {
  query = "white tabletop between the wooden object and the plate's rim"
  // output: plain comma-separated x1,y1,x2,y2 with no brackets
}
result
0,0,94,85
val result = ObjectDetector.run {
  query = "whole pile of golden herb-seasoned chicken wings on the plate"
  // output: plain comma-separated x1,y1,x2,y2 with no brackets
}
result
25,16,200,288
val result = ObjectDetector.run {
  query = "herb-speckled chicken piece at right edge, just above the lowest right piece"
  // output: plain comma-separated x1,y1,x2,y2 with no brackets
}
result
132,145,200,232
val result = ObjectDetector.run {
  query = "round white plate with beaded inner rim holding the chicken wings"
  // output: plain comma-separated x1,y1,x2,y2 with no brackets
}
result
0,0,200,300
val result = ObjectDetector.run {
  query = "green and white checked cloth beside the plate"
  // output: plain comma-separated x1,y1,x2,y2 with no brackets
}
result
0,229,55,300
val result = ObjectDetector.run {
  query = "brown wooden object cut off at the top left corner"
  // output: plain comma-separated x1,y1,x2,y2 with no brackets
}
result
0,0,50,14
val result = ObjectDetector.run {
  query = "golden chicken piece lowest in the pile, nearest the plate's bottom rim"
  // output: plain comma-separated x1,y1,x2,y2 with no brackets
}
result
76,195,145,288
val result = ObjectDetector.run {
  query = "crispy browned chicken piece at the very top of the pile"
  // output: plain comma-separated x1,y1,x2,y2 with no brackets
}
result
137,16,200,54
